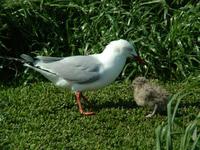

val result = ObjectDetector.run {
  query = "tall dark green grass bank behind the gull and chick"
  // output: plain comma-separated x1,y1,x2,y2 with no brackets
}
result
0,0,200,81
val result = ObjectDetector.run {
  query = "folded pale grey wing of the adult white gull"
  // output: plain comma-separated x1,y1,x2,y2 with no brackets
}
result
38,56,101,84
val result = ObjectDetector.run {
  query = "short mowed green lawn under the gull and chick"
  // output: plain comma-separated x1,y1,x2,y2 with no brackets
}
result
0,82,200,150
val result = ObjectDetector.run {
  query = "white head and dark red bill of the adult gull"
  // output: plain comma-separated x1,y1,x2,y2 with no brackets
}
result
105,39,144,64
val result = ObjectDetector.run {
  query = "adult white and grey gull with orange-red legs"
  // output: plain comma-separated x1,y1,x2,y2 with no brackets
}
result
21,39,143,115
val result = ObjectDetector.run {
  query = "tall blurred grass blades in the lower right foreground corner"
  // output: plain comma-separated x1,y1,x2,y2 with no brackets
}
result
156,76,200,150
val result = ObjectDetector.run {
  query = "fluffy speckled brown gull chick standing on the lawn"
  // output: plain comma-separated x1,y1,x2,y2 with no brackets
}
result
132,77,169,117
